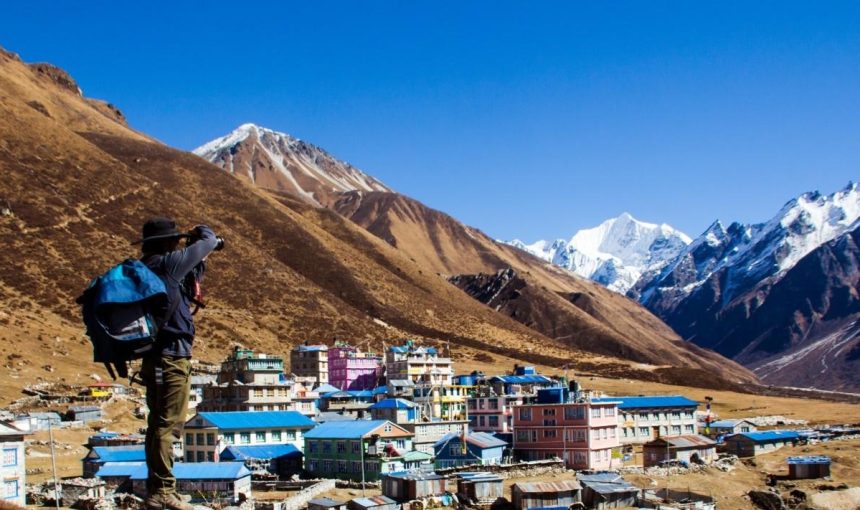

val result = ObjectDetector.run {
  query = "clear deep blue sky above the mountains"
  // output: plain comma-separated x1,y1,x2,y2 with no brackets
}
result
0,1,860,241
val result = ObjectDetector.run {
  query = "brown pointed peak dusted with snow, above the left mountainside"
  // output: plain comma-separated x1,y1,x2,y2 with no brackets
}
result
193,124,391,205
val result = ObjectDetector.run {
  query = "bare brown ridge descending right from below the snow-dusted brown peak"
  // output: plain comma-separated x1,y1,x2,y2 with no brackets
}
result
333,192,755,381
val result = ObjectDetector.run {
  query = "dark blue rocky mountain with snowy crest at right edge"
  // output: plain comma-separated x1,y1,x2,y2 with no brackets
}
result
629,184,860,391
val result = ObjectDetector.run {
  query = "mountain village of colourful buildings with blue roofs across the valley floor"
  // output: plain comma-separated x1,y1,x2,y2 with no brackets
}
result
2,340,860,510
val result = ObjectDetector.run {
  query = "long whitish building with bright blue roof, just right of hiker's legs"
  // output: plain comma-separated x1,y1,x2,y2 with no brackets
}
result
184,411,317,462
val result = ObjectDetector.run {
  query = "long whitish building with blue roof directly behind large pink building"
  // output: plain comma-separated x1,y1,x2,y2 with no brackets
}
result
591,395,699,445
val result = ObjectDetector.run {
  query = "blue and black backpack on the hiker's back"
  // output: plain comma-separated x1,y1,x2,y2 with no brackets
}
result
76,259,176,380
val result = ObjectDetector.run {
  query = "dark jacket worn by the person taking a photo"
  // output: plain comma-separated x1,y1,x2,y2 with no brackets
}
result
143,225,218,358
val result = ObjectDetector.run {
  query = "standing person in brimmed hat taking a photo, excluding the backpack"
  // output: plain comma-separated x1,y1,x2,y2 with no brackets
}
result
138,218,223,510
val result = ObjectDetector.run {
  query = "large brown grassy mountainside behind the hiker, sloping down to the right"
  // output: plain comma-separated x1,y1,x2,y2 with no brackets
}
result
0,46,752,395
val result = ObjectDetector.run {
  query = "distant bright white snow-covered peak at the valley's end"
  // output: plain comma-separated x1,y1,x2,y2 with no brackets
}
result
509,213,691,293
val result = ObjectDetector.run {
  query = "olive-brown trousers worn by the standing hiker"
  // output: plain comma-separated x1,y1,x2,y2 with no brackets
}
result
140,355,191,494
